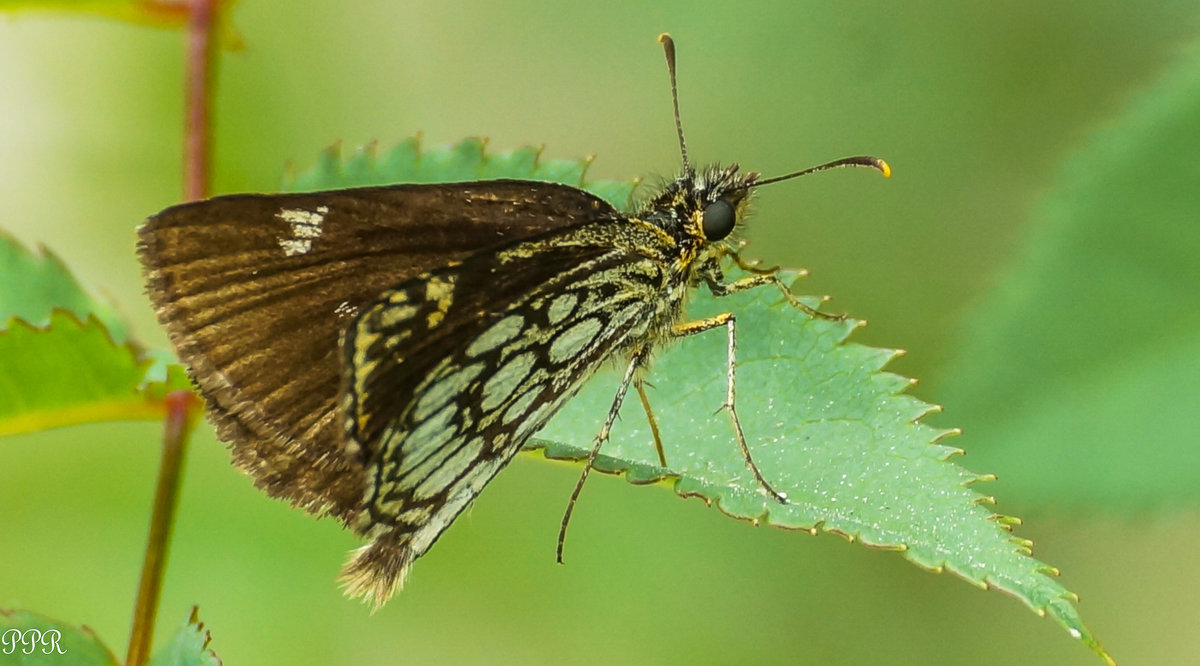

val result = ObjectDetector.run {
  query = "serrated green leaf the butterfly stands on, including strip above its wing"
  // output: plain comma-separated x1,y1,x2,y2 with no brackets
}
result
287,139,1110,660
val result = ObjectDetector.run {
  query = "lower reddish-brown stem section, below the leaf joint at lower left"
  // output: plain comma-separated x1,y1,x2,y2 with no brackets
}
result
125,391,199,666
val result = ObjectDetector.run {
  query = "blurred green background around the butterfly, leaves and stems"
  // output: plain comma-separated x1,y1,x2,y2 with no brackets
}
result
0,0,1200,665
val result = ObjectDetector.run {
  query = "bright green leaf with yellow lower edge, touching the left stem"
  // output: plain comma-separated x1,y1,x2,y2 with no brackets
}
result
0,310,188,436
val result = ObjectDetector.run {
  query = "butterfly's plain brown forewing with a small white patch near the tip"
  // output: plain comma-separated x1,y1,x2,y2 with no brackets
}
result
138,180,614,518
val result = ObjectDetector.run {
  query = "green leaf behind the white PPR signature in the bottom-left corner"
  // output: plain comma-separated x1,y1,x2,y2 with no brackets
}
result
0,608,119,666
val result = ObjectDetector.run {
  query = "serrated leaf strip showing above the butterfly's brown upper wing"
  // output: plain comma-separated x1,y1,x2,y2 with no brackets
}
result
283,137,640,209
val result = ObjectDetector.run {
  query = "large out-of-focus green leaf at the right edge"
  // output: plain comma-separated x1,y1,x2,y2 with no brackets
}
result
943,48,1200,509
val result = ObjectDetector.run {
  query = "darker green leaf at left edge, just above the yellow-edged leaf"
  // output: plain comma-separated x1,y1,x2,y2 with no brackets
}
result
0,229,128,342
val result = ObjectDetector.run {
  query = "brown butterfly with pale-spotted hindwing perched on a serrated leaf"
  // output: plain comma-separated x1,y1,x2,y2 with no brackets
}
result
138,35,890,606
